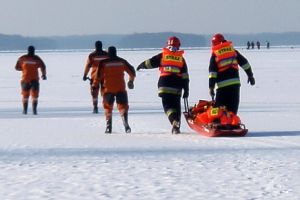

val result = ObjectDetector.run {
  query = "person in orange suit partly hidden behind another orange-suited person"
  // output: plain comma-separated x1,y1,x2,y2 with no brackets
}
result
83,41,108,113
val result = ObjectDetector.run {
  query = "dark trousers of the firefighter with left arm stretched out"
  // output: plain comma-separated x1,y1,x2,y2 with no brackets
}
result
160,94,181,124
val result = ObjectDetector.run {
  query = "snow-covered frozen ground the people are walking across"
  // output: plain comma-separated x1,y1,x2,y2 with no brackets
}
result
0,48,300,200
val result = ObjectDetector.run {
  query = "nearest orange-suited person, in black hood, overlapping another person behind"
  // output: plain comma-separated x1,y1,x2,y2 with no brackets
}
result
92,46,135,133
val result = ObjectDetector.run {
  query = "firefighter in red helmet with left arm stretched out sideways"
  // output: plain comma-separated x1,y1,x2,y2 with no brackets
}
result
137,36,189,134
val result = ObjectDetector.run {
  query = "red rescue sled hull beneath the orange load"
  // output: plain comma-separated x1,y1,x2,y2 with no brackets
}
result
183,99,248,137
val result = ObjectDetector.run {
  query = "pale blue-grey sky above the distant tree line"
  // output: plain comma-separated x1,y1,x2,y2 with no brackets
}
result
0,0,300,36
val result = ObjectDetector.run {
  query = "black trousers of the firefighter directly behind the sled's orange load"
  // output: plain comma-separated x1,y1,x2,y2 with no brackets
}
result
215,85,240,114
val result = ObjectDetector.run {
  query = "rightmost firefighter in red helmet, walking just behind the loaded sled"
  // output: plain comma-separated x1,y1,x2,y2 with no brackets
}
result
209,33,255,114
